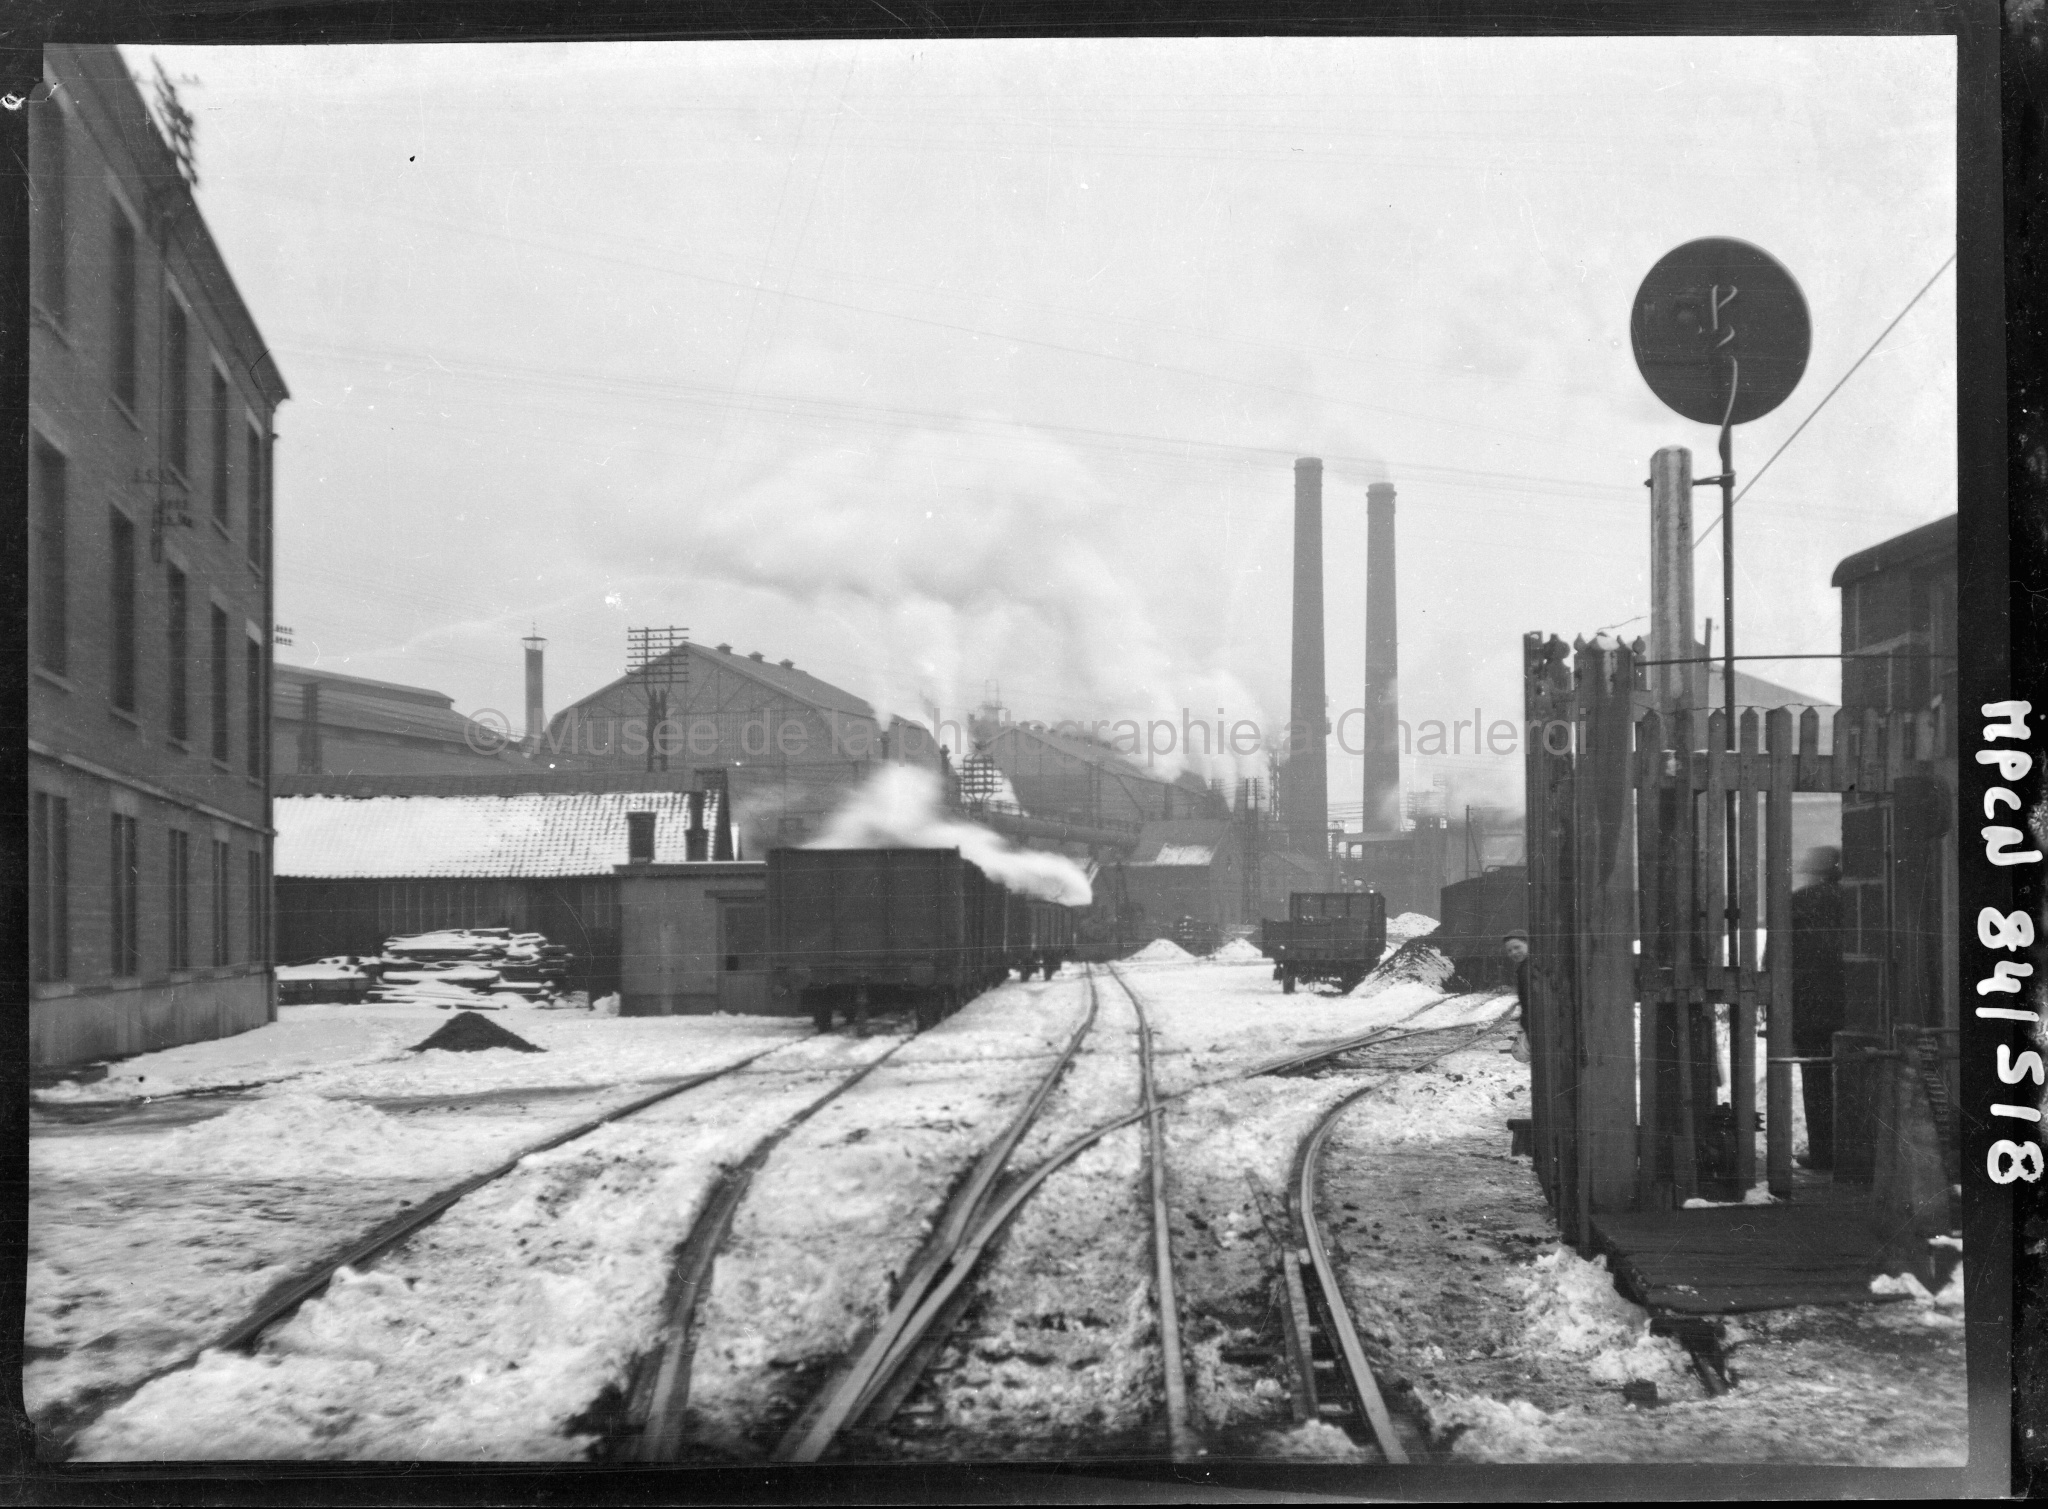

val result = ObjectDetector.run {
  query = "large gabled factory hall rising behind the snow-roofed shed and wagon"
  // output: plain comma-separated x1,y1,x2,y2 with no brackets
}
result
530,645,946,852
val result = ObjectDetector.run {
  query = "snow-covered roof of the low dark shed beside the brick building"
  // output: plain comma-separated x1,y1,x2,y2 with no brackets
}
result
270,790,719,880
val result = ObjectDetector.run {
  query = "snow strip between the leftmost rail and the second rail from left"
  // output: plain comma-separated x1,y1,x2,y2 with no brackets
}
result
66,1036,895,1460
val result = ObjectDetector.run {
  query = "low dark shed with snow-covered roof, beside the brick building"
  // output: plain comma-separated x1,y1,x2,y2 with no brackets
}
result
272,788,733,995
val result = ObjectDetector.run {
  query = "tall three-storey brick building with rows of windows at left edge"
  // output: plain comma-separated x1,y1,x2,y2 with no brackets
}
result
29,45,287,1065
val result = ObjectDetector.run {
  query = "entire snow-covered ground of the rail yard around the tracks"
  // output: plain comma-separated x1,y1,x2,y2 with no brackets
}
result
25,944,1964,1464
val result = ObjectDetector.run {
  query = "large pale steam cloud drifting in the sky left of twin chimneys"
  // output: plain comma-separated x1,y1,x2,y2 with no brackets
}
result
678,430,1270,776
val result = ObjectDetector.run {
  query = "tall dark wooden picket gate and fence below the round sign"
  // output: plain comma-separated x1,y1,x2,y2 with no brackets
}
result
1524,635,1939,1247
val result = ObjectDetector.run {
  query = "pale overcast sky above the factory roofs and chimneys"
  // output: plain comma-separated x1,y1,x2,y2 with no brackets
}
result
127,37,1956,817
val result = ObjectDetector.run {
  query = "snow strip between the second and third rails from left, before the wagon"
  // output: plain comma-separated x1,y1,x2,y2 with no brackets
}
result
686,975,1087,1460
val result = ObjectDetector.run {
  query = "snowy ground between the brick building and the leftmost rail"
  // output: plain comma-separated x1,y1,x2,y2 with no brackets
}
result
23,1011,809,1431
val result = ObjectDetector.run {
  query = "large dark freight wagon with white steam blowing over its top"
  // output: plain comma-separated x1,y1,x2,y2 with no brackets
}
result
768,850,1073,1030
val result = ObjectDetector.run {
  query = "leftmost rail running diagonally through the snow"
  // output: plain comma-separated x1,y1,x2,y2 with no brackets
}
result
47,1038,872,1454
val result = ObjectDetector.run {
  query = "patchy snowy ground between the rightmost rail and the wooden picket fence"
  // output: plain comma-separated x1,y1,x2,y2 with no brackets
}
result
1323,1048,1968,1466
